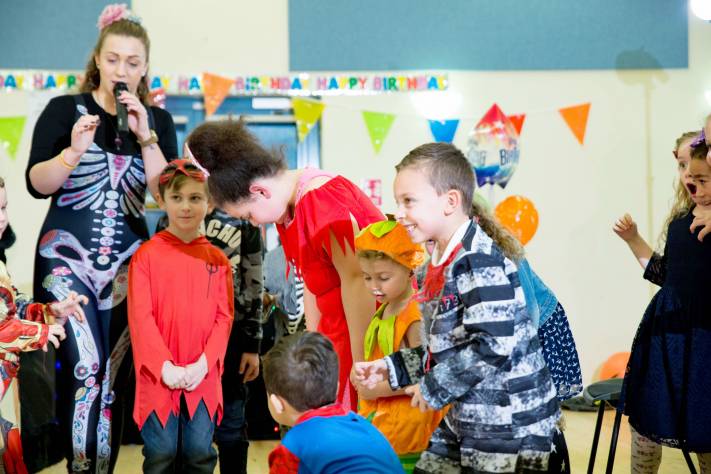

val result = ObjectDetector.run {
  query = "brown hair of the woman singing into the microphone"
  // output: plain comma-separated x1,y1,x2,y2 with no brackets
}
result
80,19,151,104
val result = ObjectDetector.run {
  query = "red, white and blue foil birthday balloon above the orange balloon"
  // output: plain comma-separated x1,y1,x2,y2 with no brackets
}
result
467,104,519,188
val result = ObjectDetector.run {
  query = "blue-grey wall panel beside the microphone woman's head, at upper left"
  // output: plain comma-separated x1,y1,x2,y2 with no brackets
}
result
0,0,119,70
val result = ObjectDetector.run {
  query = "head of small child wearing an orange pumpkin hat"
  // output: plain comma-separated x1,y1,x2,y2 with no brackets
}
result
355,220,425,303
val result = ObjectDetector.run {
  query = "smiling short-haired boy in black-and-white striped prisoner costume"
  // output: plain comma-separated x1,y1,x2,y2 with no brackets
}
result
356,143,569,473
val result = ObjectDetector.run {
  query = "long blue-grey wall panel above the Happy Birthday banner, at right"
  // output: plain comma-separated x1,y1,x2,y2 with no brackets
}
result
289,0,688,71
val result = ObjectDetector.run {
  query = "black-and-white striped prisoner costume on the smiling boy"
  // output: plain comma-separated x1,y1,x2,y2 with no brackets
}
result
386,222,560,472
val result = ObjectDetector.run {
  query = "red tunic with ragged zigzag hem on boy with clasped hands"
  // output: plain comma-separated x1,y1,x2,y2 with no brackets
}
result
128,231,234,429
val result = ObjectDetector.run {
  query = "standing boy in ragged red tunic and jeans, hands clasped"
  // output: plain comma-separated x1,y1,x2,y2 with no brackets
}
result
128,160,234,473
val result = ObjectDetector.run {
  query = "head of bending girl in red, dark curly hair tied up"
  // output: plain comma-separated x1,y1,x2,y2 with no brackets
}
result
188,120,291,225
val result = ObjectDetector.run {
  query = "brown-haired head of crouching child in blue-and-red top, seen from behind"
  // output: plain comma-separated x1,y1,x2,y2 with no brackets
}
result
263,332,338,425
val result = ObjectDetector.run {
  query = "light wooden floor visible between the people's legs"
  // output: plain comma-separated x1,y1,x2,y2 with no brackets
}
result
42,410,698,474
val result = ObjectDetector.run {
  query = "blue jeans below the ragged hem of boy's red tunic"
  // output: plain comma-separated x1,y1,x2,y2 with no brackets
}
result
141,398,217,474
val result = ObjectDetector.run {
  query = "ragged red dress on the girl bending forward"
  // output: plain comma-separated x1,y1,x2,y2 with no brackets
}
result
277,169,385,410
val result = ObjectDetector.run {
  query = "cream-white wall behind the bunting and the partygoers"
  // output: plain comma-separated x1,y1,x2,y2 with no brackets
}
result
0,0,711,382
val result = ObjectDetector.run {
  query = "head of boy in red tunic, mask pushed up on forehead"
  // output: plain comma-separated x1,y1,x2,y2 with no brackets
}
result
158,160,210,236
